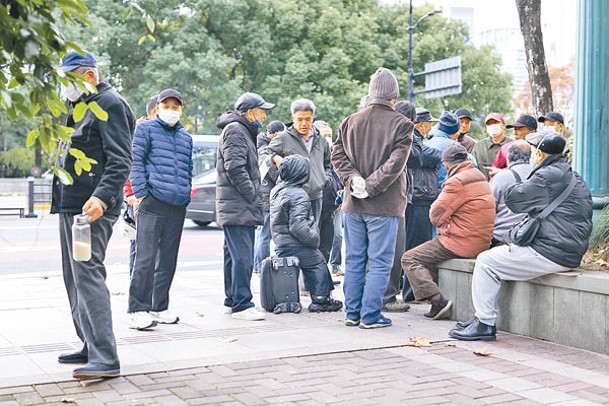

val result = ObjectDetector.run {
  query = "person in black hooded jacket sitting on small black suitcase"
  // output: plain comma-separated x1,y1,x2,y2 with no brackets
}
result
271,155,343,312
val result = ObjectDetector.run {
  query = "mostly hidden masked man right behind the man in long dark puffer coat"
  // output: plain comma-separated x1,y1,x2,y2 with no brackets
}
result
254,120,285,273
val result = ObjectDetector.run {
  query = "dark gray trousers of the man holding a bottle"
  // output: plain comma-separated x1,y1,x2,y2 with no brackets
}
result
59,213,120,368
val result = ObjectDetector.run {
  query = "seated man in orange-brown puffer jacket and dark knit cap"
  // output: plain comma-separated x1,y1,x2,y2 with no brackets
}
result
402,143,495,320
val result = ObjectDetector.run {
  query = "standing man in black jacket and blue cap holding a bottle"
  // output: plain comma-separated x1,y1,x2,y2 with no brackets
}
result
51,51,135,379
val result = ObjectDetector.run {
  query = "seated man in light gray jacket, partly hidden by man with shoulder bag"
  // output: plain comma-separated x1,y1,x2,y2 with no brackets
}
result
490,140,531,246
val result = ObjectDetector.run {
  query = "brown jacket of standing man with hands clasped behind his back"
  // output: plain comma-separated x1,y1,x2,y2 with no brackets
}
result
332,100,414,217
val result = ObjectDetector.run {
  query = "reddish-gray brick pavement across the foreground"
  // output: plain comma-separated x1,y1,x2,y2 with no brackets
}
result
0,332,609,406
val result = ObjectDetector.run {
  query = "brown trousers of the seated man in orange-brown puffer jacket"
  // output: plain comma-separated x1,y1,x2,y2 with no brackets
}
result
402,238,460,300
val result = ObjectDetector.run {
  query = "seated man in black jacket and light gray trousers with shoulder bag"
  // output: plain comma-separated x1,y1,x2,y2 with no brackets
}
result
449,132,592,341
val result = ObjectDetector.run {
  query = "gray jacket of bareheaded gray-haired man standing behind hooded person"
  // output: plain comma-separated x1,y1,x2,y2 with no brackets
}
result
259,127,331,200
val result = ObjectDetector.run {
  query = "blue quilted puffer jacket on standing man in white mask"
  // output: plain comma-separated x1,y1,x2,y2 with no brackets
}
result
129,117,192,206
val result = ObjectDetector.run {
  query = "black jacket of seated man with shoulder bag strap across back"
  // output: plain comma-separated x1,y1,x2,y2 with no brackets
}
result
505,154,592,268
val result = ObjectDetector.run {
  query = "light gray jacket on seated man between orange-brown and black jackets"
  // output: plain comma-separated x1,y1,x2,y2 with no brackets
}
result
490,161,531,241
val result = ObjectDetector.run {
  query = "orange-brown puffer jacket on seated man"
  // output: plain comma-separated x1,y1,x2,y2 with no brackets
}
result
429,161,495,258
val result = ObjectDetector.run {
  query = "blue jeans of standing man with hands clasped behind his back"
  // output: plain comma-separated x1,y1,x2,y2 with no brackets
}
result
344,212,398,324
